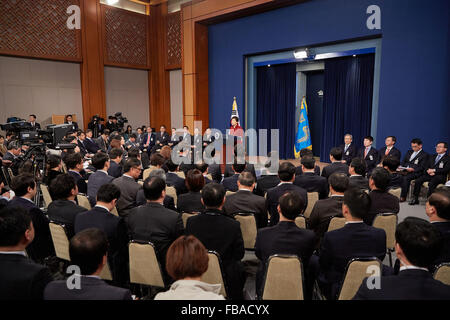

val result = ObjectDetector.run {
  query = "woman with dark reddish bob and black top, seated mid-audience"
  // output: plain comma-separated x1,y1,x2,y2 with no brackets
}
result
177,169,205,212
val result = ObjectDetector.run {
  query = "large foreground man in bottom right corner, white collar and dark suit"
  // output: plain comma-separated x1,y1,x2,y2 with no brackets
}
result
353,217,450,300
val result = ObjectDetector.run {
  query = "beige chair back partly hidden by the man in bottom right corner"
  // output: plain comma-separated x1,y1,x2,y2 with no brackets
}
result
338,257,381,300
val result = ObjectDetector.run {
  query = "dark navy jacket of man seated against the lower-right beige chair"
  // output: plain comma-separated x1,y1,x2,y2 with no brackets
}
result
318,223,386,299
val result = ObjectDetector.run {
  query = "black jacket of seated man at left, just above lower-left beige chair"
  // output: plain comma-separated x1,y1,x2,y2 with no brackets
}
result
47,200,87,239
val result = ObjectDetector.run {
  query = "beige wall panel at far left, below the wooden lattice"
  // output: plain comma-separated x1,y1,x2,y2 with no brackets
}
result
0,56,83,127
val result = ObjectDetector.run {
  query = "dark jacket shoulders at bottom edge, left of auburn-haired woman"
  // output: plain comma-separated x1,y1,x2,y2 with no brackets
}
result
44,276,132,300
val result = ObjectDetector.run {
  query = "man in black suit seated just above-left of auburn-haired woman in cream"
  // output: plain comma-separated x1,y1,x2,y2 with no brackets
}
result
128,177,184,274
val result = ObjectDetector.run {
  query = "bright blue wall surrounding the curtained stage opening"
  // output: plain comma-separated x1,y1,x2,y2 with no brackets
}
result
209,0,450,154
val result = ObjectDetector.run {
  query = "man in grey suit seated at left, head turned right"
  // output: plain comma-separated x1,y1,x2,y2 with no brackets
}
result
112,158,142,217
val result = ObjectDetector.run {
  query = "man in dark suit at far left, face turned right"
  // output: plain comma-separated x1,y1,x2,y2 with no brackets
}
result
8,174,55,262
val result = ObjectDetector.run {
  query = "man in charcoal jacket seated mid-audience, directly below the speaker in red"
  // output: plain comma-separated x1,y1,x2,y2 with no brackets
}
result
223,171,267,228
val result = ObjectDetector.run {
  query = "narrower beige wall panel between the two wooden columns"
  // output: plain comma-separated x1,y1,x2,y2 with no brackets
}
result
105,67,150,130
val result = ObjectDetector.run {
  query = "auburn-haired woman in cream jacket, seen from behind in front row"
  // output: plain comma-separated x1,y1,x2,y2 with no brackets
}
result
155,235,225,300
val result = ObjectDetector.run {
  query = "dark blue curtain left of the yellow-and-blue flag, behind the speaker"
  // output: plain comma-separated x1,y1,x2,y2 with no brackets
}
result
256,63,298,159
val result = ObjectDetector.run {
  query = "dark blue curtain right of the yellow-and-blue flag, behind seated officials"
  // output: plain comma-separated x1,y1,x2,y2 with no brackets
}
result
320,54,375,162
